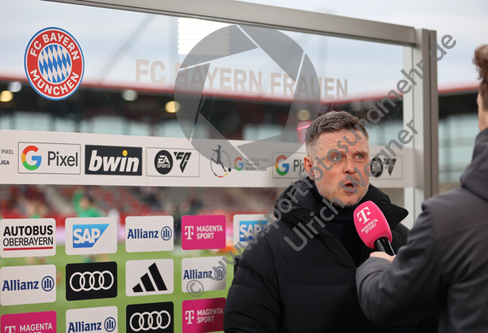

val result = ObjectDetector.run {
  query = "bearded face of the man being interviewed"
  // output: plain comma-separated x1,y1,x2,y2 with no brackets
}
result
304,130,369,207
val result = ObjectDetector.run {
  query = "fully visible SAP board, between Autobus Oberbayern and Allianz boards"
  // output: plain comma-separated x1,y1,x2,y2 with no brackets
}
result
65,217,117,255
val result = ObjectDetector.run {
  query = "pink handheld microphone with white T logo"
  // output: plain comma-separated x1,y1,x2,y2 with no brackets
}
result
354,201,395,256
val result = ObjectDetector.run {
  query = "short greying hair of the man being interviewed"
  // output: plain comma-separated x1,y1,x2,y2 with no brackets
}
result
305,111,369,157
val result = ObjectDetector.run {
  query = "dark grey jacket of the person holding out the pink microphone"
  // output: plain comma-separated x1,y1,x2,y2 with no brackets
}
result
357,129,488,333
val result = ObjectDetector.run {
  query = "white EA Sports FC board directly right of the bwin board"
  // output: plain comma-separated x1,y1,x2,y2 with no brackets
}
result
146,148,200,177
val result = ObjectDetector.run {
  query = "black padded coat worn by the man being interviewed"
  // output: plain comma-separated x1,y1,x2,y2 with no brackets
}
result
224,179,436,333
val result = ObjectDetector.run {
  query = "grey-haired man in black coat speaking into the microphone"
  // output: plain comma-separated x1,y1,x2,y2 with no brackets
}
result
224,112,436,333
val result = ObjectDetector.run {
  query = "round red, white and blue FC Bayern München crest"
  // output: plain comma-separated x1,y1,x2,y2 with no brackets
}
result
24,28,85,100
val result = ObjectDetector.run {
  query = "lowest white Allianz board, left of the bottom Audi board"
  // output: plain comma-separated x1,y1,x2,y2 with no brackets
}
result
66,306,118,333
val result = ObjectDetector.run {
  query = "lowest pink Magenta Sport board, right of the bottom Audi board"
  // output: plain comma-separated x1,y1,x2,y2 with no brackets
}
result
182,297,225,333
